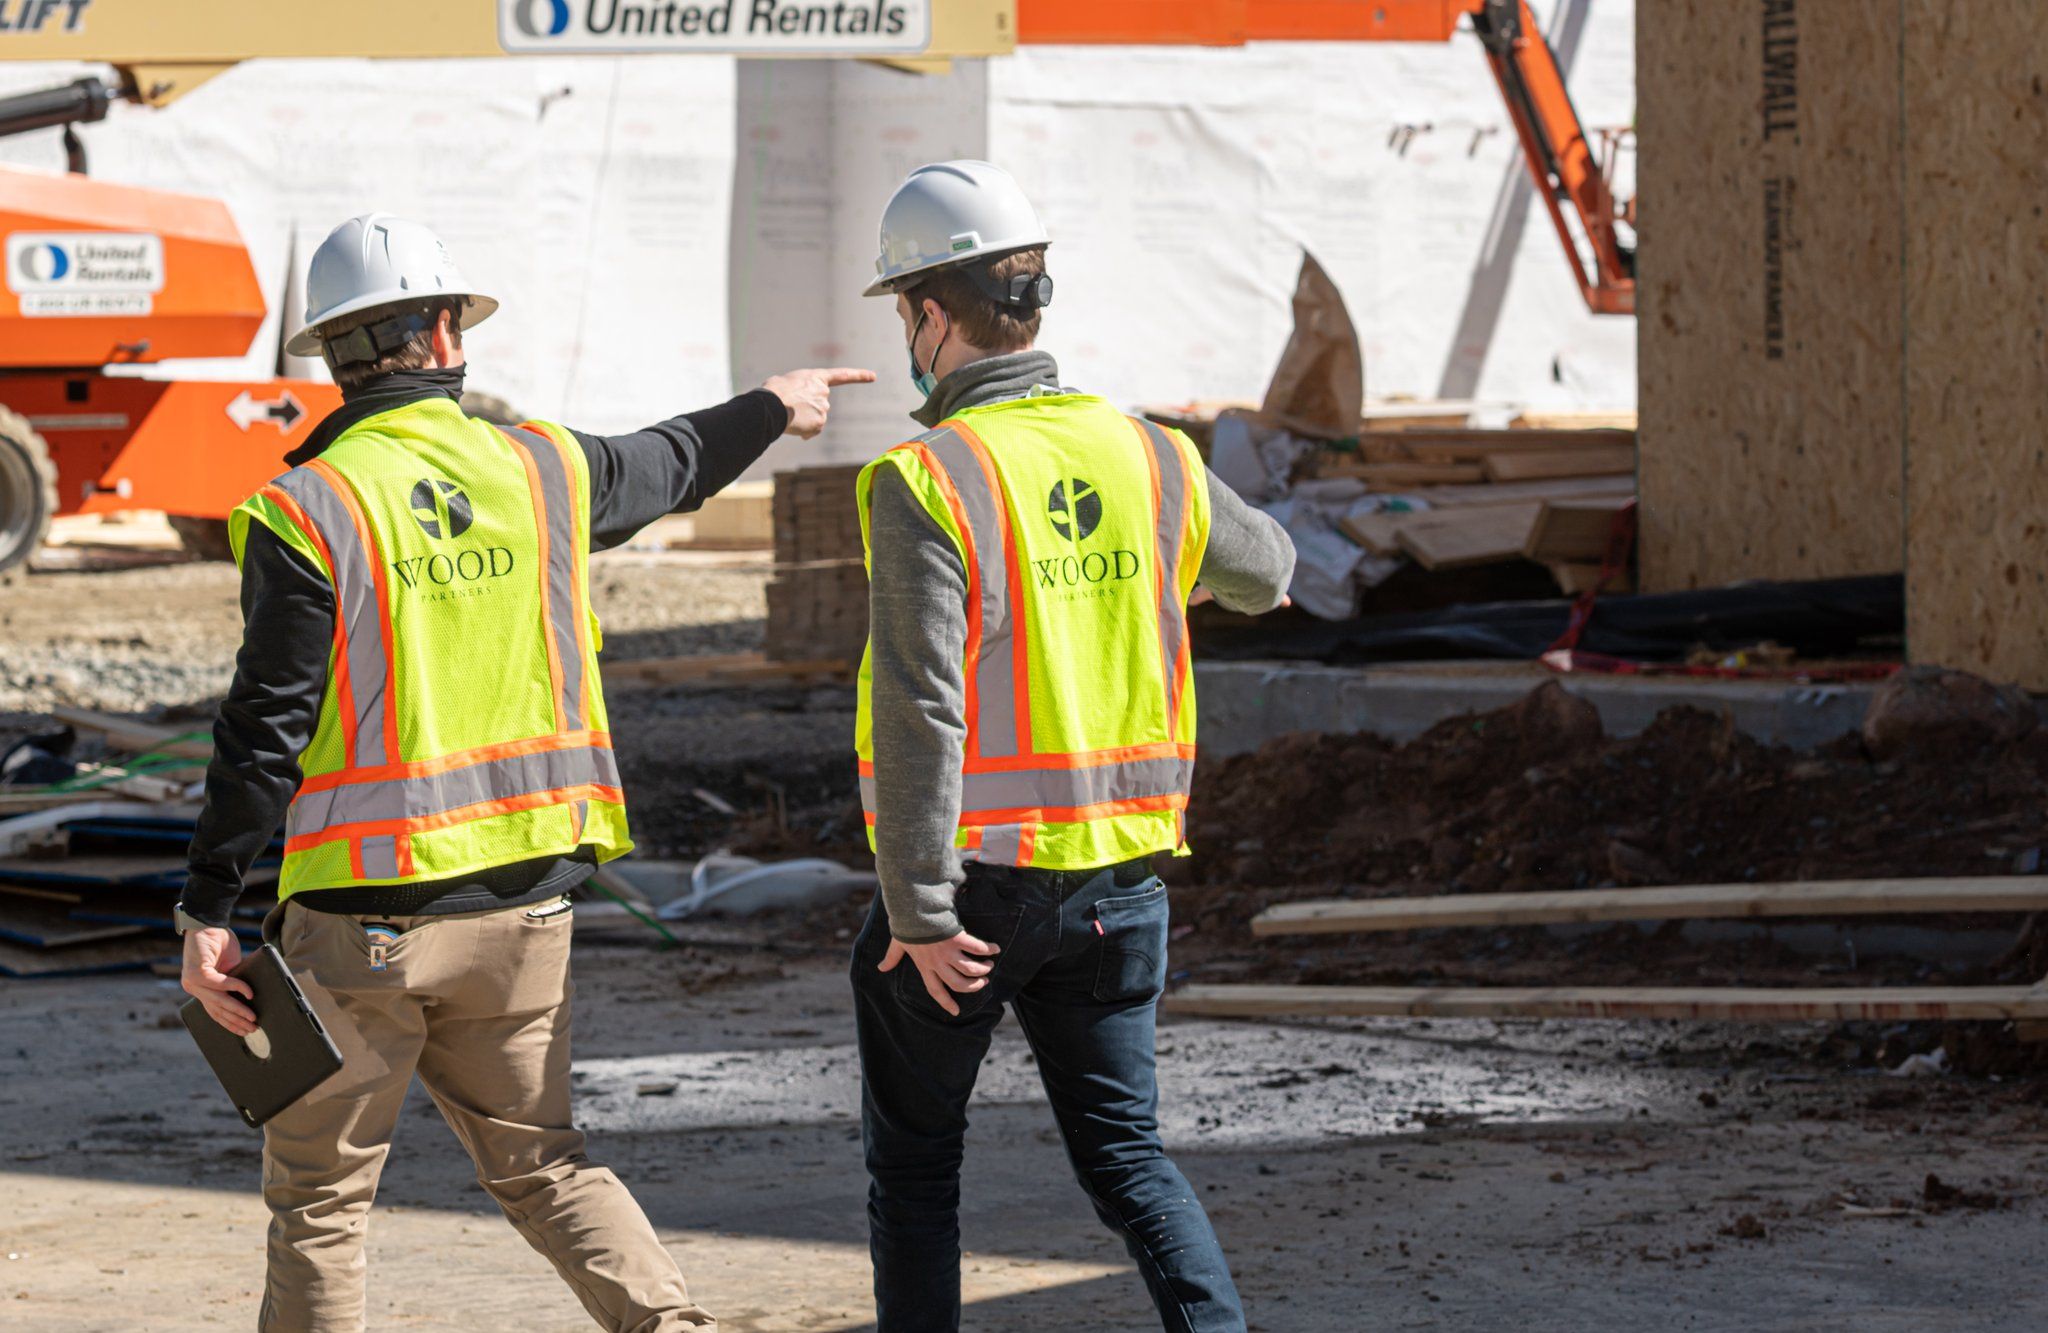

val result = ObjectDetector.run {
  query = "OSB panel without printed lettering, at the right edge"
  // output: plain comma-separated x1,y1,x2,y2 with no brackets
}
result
1905,0,2048,690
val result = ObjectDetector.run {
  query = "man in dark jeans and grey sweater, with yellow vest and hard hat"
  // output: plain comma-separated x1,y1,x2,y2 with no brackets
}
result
852,162,1294,1333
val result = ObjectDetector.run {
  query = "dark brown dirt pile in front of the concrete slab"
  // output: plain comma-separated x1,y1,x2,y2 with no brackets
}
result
1180,682,2048,909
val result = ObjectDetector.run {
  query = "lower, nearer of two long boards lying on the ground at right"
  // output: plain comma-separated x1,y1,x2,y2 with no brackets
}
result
1165,985,2048,1022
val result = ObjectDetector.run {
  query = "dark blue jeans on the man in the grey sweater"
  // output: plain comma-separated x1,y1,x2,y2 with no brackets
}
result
854,862,1245,1333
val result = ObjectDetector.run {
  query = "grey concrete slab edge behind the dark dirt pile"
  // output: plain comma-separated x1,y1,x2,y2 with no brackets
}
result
1194,661,1876,756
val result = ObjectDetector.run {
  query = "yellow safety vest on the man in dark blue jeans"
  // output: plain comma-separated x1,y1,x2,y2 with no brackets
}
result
856,393,1208,870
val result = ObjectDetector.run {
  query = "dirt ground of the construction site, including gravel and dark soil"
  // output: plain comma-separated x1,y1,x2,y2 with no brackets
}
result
0,553,2048,1333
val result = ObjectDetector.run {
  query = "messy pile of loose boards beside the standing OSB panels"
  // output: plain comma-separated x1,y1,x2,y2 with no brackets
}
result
1313,428,1636,592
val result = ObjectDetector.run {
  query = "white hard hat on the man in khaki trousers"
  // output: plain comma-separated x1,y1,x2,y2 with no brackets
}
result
285,213,498,356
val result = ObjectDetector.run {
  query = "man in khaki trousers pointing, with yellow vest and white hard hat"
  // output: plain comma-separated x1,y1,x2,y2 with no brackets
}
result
176,213,872,1333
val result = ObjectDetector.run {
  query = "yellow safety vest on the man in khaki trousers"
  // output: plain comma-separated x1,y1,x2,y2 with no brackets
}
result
227,397,633,897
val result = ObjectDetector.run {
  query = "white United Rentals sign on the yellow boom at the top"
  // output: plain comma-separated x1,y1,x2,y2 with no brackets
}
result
498,0,932,55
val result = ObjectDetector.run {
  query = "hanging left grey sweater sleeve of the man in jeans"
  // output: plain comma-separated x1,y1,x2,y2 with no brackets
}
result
868,467,967,944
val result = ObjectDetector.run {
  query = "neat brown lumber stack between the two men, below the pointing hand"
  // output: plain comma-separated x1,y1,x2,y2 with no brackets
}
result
766,467,868,661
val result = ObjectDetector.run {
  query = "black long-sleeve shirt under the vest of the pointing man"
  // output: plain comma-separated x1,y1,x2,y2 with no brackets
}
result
182,373,788,926
